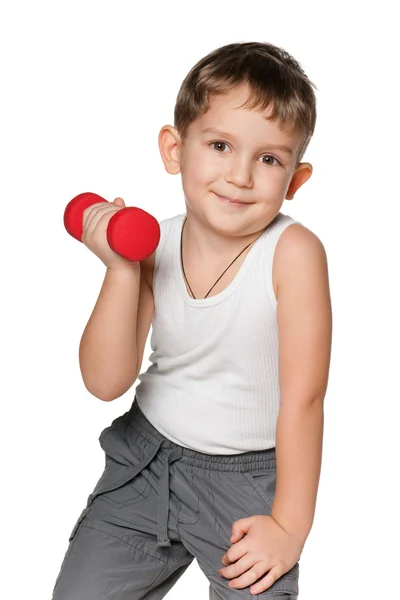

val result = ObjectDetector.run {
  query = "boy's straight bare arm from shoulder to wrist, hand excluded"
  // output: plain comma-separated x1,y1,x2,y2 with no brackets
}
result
271,225,332,542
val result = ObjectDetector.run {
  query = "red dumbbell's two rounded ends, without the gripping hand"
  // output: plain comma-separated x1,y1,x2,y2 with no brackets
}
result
64,192,160,261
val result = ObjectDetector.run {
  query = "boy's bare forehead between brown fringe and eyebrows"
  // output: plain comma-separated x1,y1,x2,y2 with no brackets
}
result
192,86,299,151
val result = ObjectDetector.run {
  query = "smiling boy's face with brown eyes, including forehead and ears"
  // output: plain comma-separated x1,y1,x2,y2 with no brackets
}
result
160,88,312,234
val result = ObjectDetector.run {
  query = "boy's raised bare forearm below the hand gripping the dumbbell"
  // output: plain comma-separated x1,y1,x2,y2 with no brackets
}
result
79,263,141,401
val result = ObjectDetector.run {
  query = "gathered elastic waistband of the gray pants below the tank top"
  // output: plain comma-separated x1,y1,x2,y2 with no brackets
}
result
123,396,276,472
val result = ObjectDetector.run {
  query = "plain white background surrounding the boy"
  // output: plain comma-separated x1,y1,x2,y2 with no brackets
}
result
0,0,400,600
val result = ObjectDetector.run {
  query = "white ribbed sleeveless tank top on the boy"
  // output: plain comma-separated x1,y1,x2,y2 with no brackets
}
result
136,213,299,454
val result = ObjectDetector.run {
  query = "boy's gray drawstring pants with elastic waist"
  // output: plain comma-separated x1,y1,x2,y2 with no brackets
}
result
53,398,299,600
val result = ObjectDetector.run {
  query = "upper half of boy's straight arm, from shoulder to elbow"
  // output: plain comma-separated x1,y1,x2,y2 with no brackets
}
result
276,223,332,407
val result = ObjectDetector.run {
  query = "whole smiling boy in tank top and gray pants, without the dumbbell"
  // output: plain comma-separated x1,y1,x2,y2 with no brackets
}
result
53,43,332,600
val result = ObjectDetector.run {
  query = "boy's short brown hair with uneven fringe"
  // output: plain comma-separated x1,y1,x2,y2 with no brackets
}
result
174,42,318,166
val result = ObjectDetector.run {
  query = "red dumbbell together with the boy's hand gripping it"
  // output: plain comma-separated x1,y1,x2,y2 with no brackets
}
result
64,192,160,266
